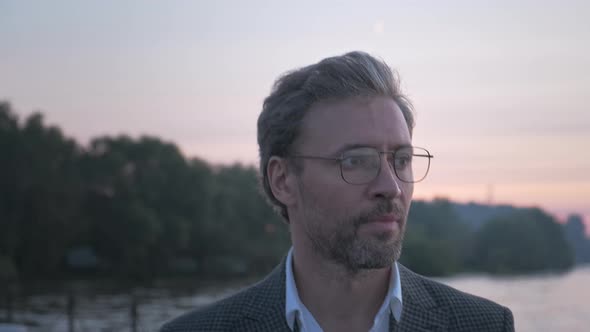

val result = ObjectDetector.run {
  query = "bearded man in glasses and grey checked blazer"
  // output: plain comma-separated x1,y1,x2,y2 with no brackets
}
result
162,52,514,332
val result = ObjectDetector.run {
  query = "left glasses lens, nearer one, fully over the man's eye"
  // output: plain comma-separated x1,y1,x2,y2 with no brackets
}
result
340,148,381,184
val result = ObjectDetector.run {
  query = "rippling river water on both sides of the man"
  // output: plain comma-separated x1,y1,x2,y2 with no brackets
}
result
0,266,590,332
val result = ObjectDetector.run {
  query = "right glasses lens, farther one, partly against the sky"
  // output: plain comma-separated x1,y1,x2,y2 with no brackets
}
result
393,147,430,182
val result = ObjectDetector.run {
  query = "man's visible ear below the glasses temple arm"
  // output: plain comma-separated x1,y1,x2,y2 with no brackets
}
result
266,156,297,206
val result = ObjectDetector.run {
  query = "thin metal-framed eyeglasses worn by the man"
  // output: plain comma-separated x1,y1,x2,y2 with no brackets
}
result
291,146,434,184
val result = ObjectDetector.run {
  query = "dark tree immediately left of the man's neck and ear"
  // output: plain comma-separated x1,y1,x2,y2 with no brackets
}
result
207,164,290,273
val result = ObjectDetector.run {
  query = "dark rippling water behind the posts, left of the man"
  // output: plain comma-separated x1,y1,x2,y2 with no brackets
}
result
0,288,243,332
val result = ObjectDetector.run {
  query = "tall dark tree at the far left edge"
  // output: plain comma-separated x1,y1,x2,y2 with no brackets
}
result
0,103,81,278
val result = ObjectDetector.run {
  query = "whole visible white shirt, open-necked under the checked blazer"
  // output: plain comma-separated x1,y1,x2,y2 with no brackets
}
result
285,248,402,332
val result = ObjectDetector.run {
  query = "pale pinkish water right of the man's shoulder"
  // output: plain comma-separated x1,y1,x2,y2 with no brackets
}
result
438,266,590,332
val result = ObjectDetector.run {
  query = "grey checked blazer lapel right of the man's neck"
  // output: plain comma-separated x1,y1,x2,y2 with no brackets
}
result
389,263,448,332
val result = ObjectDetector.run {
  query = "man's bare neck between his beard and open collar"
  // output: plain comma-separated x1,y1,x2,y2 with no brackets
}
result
293,244,391,331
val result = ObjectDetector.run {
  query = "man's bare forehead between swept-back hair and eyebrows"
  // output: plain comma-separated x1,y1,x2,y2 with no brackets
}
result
298,97,411,153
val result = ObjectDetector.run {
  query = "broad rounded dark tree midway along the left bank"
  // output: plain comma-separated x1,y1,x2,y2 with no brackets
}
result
84,136,207,278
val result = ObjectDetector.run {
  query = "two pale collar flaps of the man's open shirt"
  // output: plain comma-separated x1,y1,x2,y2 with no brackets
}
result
285,247,402,330
